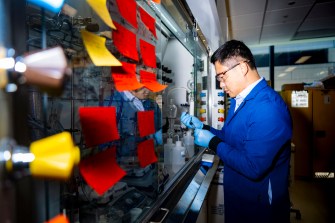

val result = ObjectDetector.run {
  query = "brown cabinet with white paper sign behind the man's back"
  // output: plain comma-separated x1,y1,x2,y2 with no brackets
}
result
281,89,335,178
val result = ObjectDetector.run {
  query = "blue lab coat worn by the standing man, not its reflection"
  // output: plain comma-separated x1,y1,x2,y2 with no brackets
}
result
210,79,292,223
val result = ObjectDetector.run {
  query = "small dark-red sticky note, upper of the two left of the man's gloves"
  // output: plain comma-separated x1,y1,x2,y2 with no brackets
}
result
137,111,155,137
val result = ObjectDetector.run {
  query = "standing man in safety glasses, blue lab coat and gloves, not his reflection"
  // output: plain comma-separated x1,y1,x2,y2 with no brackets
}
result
181,40,292,223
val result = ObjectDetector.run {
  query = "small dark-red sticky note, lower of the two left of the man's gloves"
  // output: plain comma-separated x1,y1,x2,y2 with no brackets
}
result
137,139,158,168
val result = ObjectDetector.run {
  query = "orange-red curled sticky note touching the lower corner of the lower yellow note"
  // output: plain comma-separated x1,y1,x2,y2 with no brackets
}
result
112,62,144,91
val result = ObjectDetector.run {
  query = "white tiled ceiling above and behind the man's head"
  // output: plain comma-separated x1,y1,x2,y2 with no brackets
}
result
217,0,335,45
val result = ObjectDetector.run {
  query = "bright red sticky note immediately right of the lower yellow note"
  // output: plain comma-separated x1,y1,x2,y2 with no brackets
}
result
112,22,138,61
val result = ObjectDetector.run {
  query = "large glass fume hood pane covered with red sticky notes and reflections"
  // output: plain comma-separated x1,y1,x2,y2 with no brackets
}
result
23,0,208,222
